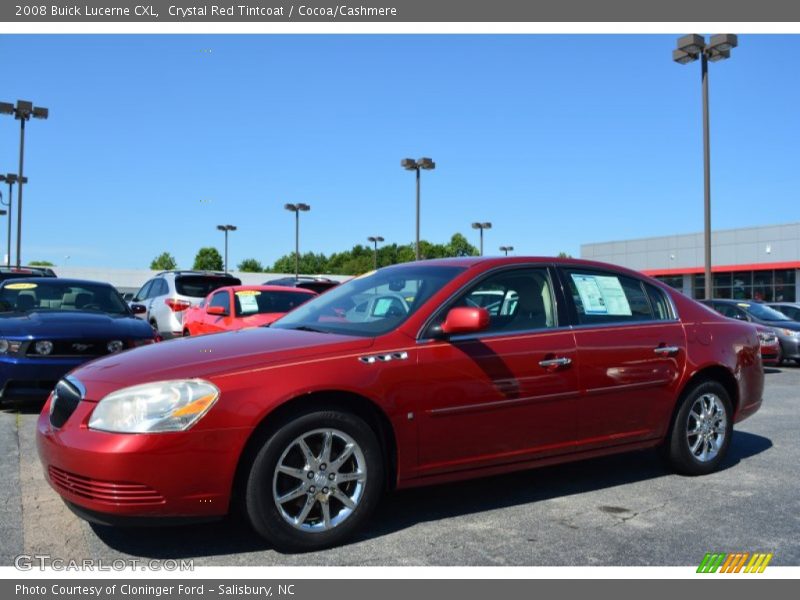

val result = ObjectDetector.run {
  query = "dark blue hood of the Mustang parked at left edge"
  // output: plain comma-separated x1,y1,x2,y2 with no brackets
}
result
0,310,153,339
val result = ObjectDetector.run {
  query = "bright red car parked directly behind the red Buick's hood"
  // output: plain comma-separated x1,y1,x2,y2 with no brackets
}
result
183,285,317,336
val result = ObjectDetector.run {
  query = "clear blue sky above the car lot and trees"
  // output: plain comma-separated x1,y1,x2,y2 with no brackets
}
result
0,32,800,268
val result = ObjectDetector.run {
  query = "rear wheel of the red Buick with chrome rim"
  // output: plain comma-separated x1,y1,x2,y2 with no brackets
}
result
667,381,733,475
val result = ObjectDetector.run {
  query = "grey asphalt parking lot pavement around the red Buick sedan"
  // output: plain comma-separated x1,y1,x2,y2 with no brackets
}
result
0,367,800,566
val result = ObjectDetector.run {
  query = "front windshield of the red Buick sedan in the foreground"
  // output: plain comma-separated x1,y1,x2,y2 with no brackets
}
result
272,265,464,337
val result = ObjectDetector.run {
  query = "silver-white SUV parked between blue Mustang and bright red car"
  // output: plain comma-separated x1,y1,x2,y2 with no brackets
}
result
131,271,242,338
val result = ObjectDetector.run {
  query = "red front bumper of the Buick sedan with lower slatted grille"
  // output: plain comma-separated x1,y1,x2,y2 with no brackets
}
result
36,400,250,521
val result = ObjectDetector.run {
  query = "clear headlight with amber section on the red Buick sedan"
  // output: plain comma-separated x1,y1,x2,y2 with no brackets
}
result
89,379,219,433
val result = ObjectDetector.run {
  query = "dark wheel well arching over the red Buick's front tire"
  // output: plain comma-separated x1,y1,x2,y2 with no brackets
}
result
232,390,397,504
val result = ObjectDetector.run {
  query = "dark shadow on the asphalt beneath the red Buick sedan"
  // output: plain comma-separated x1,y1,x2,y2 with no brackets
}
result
86,431,772,559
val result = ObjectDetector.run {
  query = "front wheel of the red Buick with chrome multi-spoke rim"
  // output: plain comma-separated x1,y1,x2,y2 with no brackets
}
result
245,410,384,552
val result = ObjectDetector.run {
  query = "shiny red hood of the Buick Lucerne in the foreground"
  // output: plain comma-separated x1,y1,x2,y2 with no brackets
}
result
71,327,374,400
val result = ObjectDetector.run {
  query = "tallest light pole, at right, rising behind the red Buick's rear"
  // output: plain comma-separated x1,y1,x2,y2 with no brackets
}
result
672,33,738,300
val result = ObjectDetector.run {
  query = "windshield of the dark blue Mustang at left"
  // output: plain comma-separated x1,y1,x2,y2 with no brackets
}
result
0,278,130,315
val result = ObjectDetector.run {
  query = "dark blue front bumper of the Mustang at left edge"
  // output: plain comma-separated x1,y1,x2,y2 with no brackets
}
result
0,356,86,401
